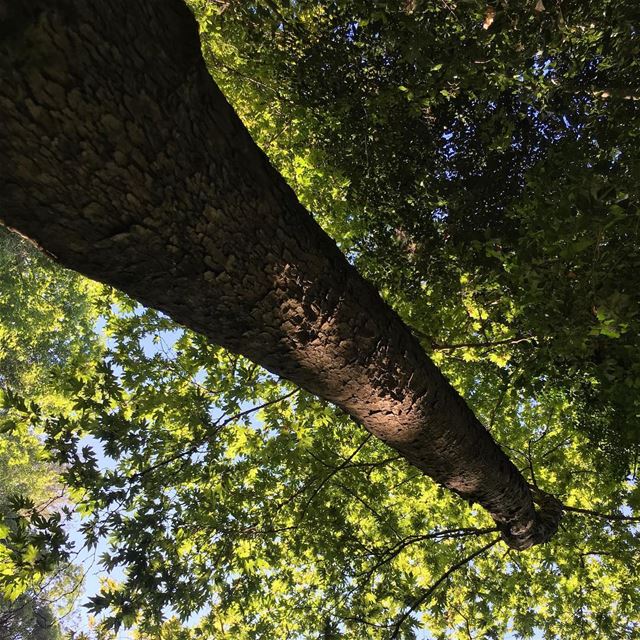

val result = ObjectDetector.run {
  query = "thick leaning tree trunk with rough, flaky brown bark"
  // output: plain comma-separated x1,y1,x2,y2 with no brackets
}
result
0,0,559,549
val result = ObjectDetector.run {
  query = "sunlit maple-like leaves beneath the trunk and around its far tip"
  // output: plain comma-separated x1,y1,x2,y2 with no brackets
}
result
12,292,640,638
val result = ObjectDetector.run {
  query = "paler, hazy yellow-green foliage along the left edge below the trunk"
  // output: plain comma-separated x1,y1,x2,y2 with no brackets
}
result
0,234,100,640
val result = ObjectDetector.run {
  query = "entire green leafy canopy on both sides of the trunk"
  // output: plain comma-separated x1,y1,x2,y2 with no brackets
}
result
0,0,640,639
